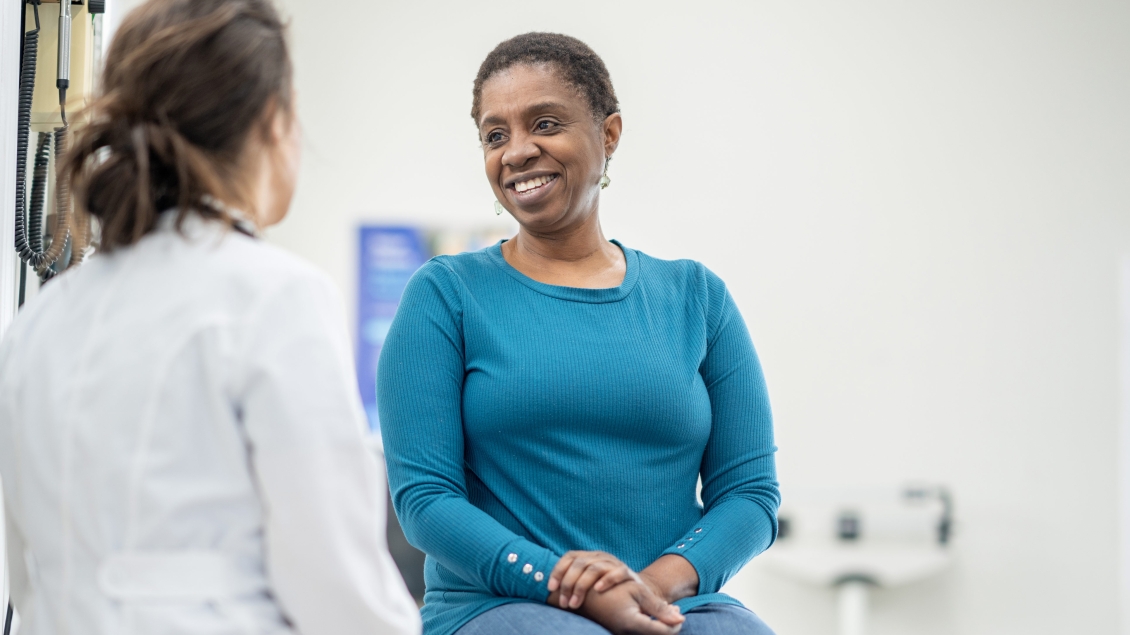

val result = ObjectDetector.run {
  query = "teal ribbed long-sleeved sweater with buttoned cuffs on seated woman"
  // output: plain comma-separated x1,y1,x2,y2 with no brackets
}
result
377,243,780,635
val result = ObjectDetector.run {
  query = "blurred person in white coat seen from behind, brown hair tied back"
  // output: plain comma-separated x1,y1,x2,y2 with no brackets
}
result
0,0,419,635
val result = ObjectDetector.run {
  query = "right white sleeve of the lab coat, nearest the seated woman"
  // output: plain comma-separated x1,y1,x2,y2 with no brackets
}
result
236,275,420,635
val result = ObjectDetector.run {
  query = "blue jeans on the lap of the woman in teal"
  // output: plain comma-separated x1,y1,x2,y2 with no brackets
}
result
455,602,773,635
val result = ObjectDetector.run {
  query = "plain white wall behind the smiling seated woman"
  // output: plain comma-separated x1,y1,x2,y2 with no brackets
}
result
114,0,1130,635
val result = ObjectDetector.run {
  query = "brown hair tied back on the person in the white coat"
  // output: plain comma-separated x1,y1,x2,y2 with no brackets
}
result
60,0,292,251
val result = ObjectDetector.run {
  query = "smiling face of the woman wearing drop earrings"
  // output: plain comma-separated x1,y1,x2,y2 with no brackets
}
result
479,64,622,233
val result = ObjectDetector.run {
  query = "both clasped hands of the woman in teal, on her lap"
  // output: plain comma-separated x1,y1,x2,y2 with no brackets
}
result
547,551,698,635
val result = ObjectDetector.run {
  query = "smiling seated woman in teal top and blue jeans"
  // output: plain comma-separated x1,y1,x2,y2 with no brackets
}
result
377,33,780,635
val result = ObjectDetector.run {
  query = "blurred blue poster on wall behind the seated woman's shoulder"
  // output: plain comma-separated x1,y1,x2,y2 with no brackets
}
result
357,227,428,432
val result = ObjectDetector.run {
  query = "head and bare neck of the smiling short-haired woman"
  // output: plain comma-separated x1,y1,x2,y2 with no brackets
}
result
471,33,625,288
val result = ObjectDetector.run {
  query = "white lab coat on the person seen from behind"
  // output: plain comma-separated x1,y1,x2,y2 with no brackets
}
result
0,212,420,635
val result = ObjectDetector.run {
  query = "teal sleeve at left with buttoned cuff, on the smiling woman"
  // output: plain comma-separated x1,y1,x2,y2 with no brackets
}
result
377,260,559,601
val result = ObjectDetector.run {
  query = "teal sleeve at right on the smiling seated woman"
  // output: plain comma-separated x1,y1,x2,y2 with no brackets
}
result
664,269,781,594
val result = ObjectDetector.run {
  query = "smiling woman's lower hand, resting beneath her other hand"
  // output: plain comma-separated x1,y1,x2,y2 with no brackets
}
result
576,581,686,635
